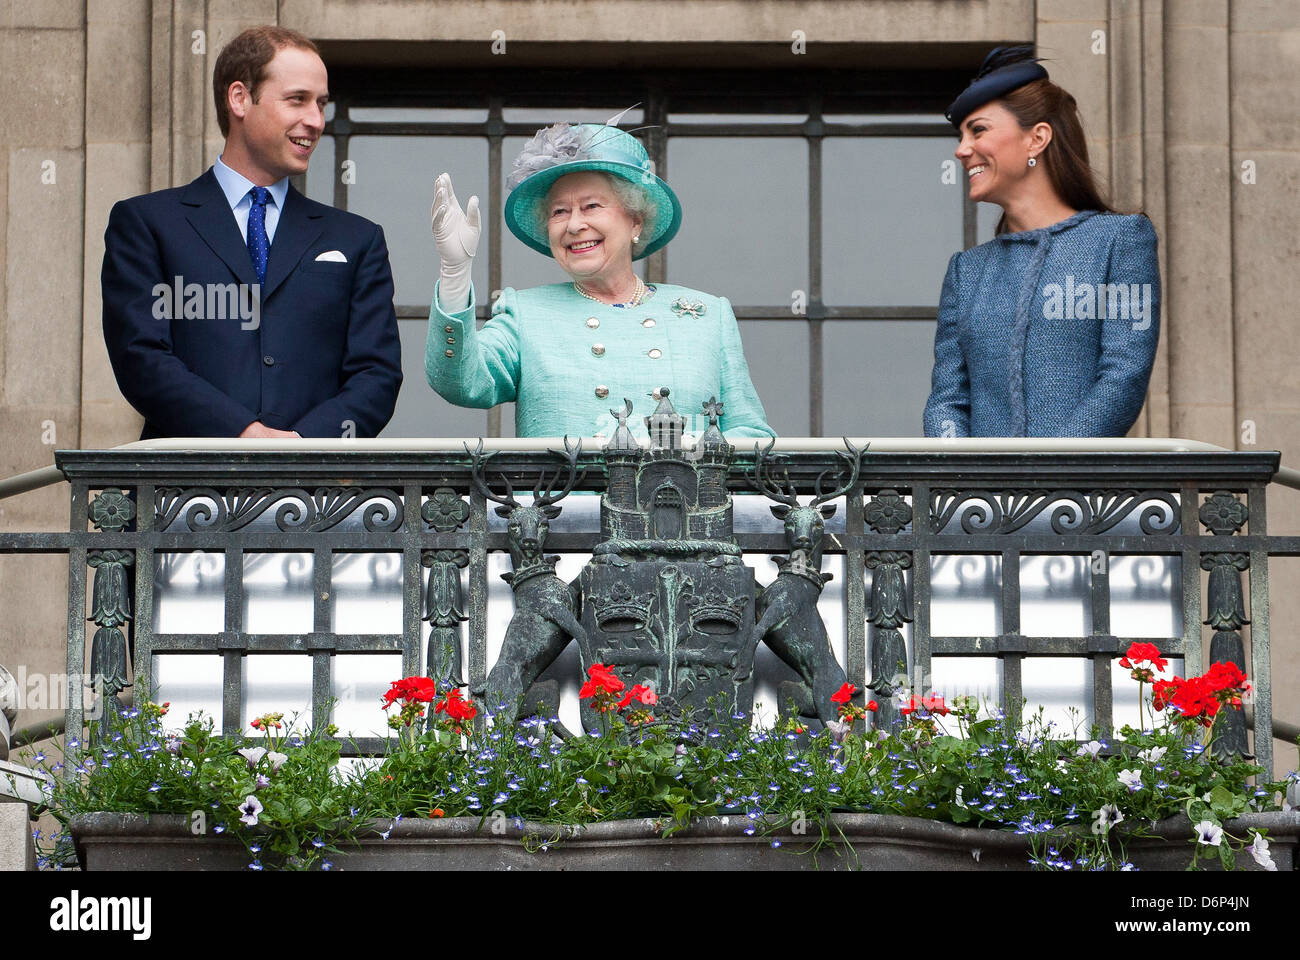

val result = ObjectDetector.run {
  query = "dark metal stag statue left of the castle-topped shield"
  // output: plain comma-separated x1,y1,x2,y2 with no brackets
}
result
465,437,585,725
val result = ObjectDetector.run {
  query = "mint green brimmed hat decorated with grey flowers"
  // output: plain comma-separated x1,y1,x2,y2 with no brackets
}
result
506,124,681,260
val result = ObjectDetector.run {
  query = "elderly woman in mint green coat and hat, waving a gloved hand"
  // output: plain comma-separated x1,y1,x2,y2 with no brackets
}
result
425,124,776,438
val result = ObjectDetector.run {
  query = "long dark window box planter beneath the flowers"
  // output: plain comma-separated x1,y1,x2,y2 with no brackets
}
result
70,810,1300,873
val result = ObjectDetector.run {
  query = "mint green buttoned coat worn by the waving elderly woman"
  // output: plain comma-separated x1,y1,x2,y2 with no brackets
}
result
425,284,776,438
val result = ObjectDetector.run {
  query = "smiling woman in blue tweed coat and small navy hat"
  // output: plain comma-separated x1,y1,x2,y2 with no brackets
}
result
924,48,1160,437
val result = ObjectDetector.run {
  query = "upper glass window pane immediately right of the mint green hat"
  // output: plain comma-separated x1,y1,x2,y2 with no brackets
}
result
667,137,806,306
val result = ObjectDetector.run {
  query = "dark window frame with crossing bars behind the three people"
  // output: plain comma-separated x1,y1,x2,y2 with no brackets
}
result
304,65,978,437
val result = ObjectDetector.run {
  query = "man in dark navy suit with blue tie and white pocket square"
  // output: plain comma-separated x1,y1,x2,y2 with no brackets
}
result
101,27,402,438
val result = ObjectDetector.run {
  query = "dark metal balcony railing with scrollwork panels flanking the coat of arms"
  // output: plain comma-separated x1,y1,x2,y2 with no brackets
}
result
38,441,1300,769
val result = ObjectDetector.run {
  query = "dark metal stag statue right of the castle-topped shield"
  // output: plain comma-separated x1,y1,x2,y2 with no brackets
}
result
750,438,862,722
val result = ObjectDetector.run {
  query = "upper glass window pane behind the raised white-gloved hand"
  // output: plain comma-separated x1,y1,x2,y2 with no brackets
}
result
347,137,493,308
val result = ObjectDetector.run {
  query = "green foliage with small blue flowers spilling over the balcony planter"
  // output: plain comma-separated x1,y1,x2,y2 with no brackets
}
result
25,705,1284,869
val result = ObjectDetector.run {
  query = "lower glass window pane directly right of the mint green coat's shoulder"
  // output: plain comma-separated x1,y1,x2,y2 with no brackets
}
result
740,320,809,437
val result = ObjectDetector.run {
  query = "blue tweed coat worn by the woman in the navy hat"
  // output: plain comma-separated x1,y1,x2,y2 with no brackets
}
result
924,211,1160,437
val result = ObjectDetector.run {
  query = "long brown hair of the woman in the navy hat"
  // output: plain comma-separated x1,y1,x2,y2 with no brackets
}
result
997,79,1115,233
